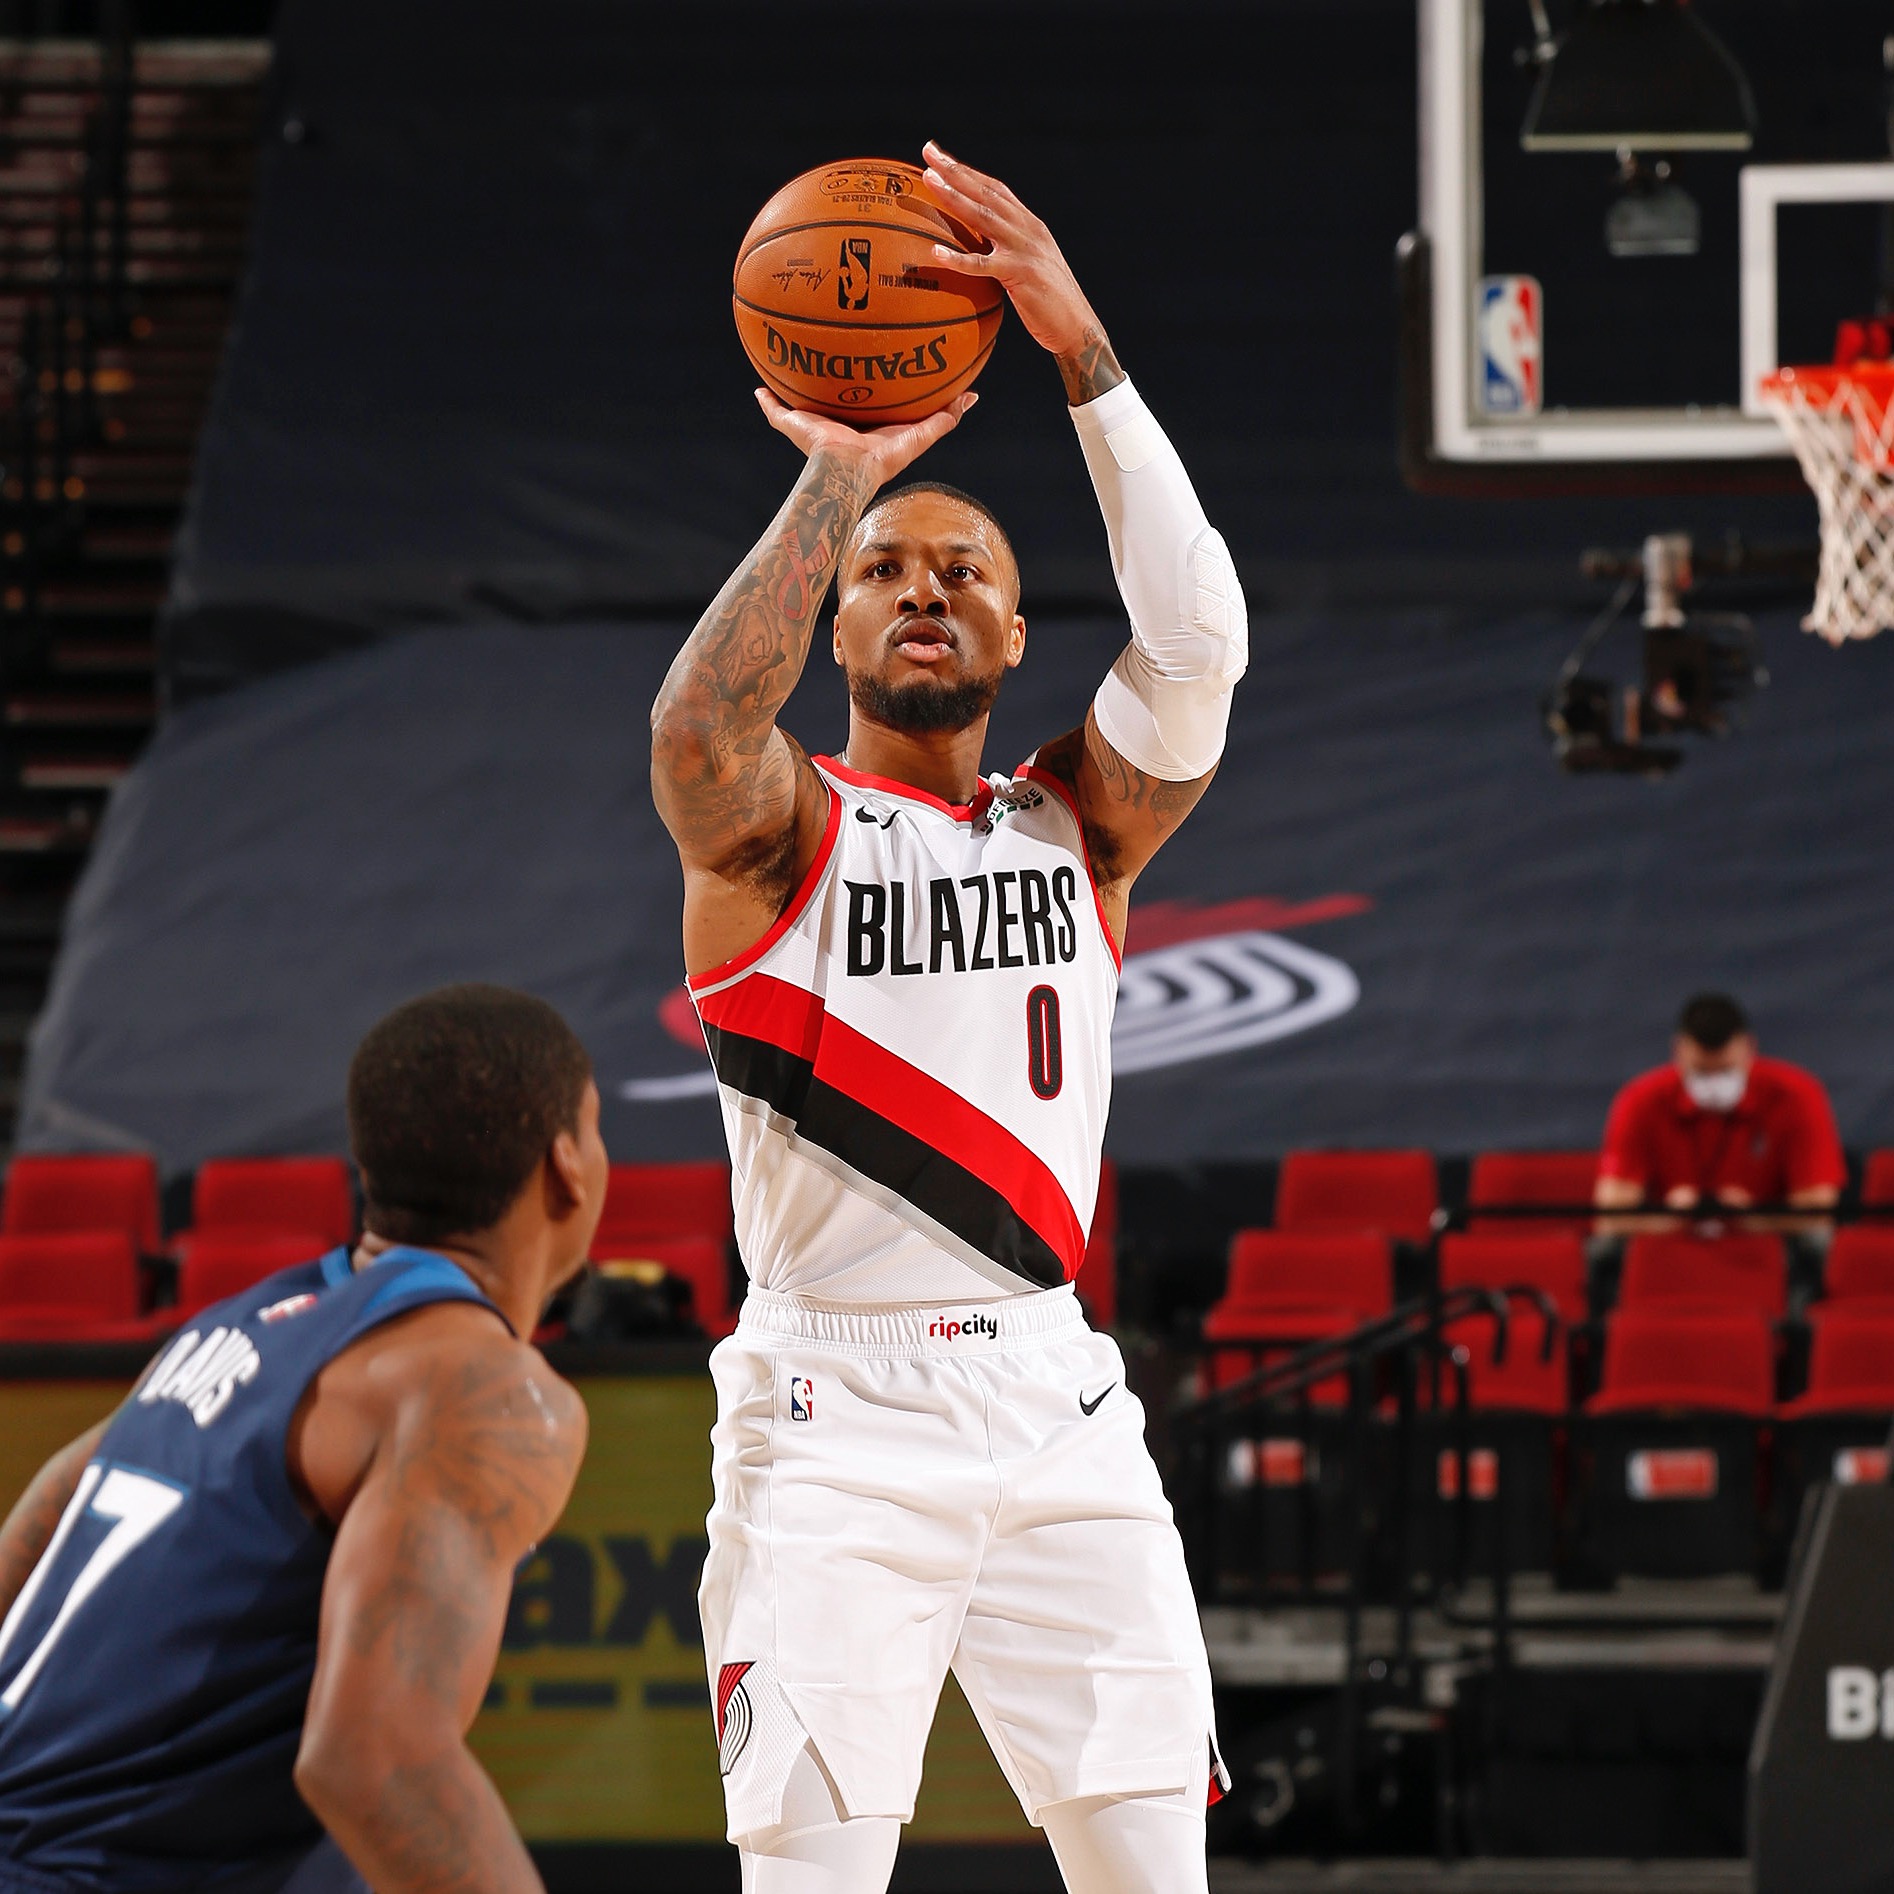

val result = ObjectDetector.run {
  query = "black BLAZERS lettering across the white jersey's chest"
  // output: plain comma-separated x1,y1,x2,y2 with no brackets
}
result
845,867,1078,979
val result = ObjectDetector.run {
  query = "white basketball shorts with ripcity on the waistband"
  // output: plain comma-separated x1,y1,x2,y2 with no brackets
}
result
697,1288,1222,1841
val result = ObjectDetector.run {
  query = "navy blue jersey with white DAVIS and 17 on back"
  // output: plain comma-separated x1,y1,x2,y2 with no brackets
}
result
0,1248,504,1894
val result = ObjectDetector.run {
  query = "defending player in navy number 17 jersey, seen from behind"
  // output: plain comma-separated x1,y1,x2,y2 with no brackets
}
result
0,987,606,1894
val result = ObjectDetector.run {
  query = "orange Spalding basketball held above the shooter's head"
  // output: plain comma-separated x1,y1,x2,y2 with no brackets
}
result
731,157,1006,426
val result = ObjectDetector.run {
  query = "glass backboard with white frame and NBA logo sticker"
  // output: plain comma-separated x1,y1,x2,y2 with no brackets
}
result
1402,0,1894,494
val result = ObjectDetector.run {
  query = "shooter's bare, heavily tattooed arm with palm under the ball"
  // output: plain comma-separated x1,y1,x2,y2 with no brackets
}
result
652,388,975,972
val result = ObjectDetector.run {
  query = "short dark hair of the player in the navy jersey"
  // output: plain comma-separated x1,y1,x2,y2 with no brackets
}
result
348,983,591,1242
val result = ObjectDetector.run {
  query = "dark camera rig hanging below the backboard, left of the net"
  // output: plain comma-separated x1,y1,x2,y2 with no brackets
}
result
1542,532,1769,777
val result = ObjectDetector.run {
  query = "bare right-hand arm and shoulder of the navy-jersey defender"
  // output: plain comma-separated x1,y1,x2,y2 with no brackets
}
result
292,1305,585,1894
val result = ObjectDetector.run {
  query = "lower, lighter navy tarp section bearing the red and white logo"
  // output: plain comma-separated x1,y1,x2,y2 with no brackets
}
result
25,606,1894,1170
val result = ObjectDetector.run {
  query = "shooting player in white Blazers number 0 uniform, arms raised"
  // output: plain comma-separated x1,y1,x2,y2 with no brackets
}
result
652,146,1246,1894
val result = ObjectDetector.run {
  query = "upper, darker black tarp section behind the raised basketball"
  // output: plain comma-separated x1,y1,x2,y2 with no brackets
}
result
165,0,1818,701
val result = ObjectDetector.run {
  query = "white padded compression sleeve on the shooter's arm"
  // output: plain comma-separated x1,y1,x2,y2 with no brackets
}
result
1072,381,1250,782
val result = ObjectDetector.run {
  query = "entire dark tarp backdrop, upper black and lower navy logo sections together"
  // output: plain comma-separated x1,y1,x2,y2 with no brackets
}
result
23,0,1894,1170
